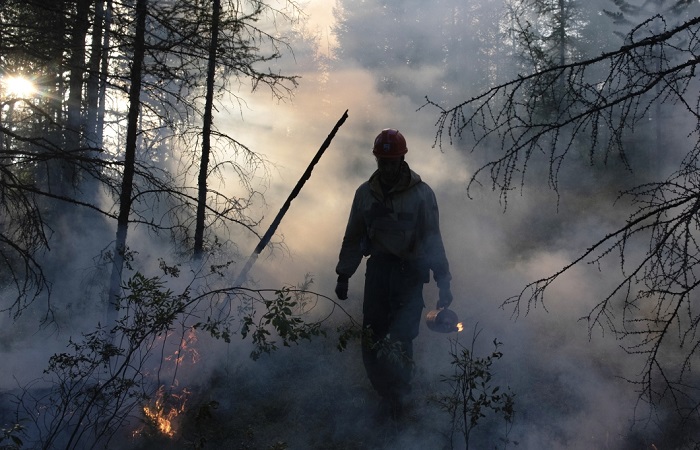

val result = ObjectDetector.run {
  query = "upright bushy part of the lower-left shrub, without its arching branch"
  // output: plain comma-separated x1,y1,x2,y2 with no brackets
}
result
10,273,188,448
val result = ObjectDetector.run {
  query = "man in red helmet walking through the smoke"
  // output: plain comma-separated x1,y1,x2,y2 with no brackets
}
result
335,129,452,418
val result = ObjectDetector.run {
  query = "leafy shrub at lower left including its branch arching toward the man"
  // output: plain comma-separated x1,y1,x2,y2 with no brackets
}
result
5,261,340,449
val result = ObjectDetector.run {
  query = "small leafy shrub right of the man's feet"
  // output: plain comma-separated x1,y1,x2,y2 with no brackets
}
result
436,330,515,449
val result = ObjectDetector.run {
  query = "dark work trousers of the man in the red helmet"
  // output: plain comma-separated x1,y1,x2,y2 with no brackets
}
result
362,255,425,400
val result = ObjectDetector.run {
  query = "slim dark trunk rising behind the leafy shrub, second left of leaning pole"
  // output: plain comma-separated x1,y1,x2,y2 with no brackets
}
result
106,0,147,320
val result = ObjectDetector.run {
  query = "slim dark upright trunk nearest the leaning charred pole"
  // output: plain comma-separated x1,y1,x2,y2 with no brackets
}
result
194,0,221,259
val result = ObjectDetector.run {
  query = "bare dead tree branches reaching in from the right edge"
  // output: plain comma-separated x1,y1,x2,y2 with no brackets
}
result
425,16,700,418
